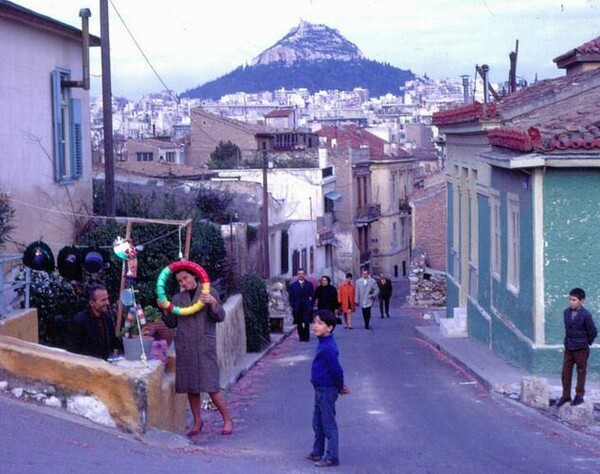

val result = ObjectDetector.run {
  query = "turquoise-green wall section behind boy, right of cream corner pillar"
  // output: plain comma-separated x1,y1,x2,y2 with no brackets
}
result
543,168,600,344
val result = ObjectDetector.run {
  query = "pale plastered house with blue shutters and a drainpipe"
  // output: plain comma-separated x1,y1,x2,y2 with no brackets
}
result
0,0,100,252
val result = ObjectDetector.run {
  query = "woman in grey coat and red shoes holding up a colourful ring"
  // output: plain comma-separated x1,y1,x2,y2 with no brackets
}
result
159,270,233,437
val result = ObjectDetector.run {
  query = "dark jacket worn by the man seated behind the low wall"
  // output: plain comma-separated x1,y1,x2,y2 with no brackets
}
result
67,308,123,359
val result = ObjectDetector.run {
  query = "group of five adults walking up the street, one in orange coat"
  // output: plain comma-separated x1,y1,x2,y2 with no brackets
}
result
288,268,392,336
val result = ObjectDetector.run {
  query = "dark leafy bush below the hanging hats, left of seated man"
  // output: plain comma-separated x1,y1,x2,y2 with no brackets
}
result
16,270,86,347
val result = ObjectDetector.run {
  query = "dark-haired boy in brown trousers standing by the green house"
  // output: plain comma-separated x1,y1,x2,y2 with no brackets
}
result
556,288,598,407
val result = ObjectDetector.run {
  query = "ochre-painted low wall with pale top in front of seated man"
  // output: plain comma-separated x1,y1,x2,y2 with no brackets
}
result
0,336,185,432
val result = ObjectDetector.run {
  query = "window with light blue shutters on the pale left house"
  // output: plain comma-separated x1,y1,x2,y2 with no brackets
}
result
52,69,83,183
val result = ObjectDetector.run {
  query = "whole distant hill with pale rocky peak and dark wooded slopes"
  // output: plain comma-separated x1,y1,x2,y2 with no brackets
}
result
182,21,414,100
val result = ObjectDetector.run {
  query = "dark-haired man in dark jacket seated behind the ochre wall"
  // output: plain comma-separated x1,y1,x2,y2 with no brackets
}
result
67,285,123,359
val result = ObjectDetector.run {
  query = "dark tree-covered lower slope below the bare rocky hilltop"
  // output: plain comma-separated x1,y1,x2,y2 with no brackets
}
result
182,59,415,100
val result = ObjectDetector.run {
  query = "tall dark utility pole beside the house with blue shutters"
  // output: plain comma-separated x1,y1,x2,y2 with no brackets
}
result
100,0,117,217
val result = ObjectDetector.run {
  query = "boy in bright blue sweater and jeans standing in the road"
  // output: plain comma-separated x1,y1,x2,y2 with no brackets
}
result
307,309,350,467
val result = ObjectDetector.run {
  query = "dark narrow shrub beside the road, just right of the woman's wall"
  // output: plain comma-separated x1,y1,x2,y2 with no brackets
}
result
242,275,271,352
